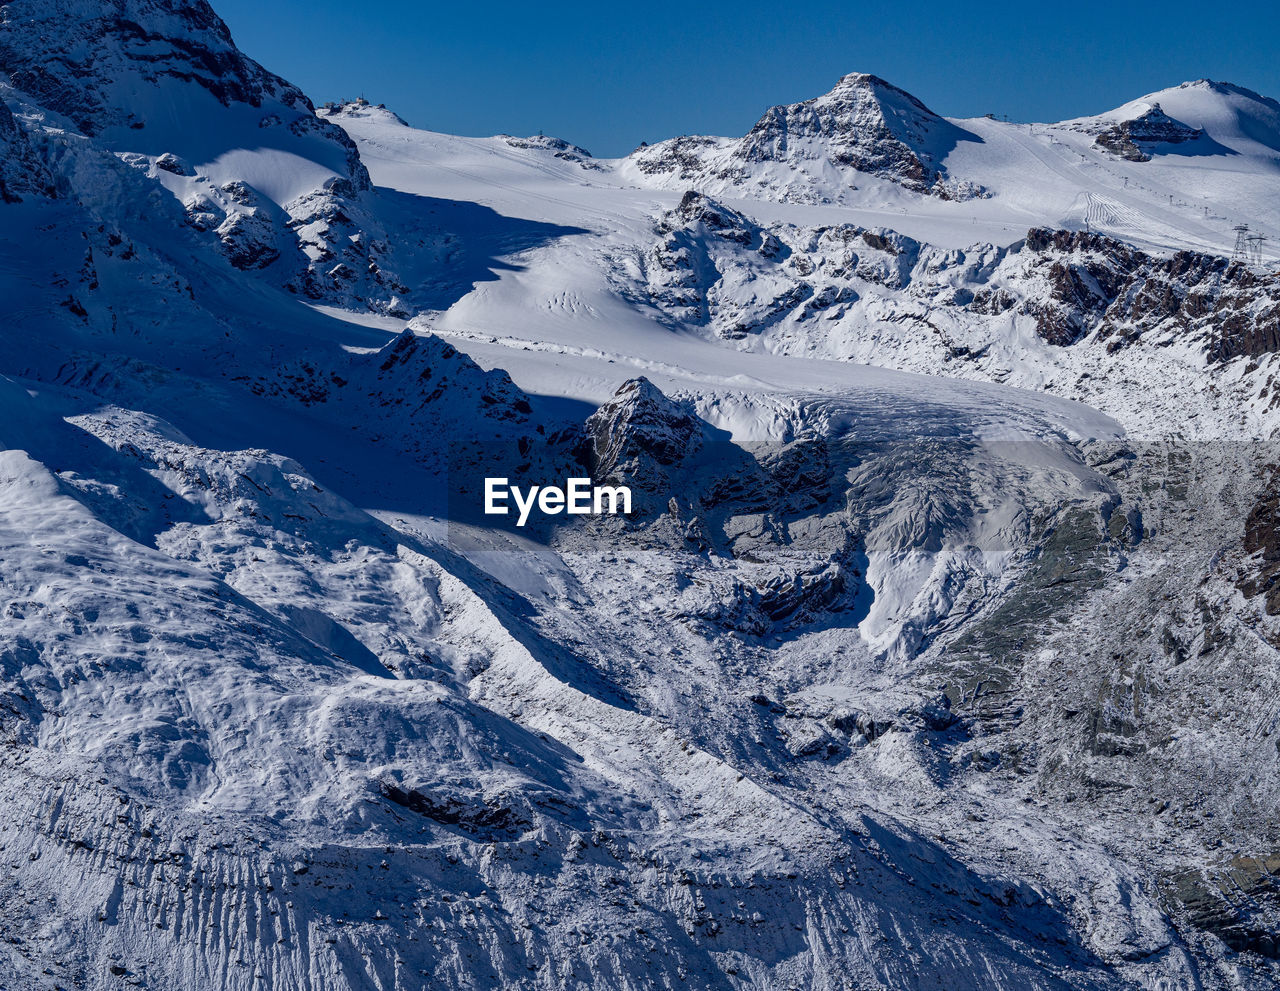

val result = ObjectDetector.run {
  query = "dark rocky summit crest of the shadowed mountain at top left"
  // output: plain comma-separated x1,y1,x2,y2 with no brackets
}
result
0,0,367,177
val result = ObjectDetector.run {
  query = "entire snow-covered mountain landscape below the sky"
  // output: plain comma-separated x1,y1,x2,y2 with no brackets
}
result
0,0,1280,990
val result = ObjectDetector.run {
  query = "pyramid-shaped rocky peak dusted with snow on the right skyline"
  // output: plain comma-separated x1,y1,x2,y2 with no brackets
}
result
628,73,982,202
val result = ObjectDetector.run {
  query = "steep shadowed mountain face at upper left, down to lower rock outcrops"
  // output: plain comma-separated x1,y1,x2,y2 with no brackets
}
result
0,0,406,309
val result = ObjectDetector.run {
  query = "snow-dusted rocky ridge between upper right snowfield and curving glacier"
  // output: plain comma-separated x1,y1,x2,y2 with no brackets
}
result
618,192,1280,427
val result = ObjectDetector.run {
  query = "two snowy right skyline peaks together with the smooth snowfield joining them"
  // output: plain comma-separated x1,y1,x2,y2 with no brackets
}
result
606,73,1280,263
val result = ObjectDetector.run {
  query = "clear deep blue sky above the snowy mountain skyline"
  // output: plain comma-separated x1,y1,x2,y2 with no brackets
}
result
211,0,1280,156
